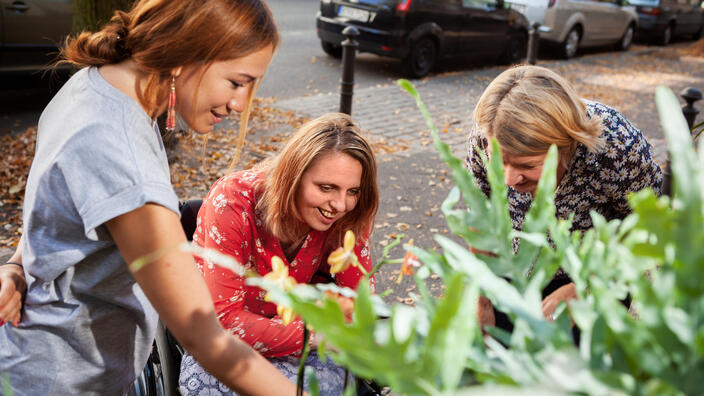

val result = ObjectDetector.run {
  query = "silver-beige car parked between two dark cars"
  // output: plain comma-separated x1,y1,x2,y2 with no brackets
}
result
508,0,640,59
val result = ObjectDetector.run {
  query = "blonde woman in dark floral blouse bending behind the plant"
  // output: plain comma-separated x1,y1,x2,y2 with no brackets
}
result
467,66,662,328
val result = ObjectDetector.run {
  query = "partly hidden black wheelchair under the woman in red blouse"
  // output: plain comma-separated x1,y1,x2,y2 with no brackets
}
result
127,200,387,396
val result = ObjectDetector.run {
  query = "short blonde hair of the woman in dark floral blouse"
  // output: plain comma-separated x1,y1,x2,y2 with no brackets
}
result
474,66,604,166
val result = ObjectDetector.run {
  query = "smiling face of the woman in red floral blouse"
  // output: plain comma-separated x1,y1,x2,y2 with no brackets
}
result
296,152,362,231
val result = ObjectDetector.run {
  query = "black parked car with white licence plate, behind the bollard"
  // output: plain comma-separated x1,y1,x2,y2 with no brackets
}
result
317,0,528,77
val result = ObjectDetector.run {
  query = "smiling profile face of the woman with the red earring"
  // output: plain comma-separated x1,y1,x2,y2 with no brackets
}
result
174,45,274,133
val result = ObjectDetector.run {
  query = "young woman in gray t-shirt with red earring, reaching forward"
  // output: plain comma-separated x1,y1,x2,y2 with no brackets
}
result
0,0,295,395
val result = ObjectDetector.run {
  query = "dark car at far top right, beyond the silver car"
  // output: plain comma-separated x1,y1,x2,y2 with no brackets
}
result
629,0,704,45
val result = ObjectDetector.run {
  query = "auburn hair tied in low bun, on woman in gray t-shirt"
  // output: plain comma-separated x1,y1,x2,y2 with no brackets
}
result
59,0,279,162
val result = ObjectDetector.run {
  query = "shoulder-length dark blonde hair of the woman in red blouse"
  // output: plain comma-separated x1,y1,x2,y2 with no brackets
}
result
257,113,379,248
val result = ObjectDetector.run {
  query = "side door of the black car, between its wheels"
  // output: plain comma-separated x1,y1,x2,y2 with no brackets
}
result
462,0,509,54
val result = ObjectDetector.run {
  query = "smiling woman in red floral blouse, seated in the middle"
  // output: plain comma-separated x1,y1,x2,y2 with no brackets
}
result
180,114,379,395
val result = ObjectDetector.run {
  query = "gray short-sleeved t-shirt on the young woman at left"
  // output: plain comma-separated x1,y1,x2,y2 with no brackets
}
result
0,68,178,395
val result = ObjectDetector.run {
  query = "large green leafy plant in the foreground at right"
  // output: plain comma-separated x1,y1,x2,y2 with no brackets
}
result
250,81,704,395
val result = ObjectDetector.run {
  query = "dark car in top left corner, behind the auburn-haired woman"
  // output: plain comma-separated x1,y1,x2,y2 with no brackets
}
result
0,0,73,74
